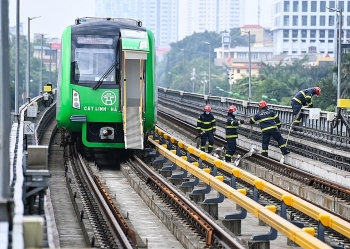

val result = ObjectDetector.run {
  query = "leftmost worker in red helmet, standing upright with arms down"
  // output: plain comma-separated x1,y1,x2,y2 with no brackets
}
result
197,105,216,153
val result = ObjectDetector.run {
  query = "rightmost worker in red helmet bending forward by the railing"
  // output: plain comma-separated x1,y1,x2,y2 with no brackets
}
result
291,86,321,132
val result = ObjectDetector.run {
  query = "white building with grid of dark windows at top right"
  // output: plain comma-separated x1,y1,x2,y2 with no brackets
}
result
271,0,350,57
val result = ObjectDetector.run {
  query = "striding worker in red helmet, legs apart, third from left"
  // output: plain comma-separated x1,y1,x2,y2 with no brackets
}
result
250,100,289,157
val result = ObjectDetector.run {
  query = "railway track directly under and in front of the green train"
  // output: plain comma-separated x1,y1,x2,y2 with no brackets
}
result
75,143,244,248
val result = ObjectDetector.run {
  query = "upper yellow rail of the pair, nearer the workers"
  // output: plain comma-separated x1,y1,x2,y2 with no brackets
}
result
156,129,350,238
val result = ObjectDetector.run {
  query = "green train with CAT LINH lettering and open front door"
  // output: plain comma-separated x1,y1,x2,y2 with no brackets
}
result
56,18,157,149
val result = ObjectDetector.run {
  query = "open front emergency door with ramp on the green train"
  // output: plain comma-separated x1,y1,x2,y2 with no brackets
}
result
121,51,147,149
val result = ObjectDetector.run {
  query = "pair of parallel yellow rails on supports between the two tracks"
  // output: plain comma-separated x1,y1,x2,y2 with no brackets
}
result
149,129,350,248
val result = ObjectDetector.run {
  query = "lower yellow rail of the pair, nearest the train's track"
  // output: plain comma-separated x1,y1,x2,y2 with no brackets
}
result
149,136,332,249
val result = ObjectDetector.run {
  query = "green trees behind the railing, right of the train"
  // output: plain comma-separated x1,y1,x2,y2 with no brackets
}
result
157,28,350,111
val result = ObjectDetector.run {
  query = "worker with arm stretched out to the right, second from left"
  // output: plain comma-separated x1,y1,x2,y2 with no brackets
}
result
225,105,248,162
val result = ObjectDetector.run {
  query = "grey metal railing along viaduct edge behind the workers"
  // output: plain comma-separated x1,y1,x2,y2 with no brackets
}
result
158,87,350,144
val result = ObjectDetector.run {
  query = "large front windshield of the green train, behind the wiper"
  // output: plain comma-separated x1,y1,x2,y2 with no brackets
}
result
73,48,116,84
